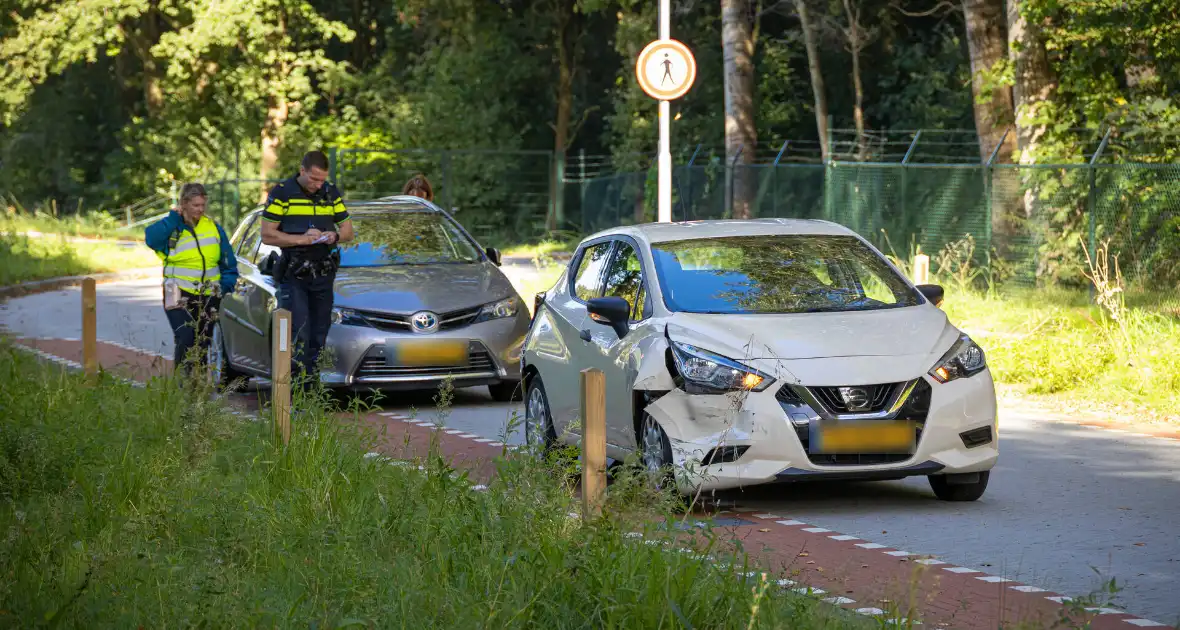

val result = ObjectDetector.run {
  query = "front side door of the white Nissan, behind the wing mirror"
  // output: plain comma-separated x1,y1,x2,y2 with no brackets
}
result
583,237,651,451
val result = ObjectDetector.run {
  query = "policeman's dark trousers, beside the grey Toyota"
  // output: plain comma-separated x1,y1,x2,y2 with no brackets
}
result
278,275,336,386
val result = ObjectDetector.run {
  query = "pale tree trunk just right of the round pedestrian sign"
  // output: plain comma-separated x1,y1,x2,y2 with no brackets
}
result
721,0,758,218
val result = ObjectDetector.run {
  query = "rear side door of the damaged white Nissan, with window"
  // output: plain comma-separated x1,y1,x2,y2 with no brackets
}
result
542,239,611,442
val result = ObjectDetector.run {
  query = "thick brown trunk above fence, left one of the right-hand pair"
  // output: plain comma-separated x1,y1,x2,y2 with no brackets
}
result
963,0,1016,163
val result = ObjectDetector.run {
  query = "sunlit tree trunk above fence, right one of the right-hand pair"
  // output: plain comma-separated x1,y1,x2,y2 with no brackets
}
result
1008,0,1057,164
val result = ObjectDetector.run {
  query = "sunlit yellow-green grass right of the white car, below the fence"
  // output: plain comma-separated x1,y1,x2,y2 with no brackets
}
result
932,237,1180,421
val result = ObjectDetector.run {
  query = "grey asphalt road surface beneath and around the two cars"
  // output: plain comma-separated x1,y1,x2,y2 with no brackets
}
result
0,276,1180,623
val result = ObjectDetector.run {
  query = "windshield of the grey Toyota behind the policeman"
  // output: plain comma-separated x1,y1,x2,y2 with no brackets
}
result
340,212,480,267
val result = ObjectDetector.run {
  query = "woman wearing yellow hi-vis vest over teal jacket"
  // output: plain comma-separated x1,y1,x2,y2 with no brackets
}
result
144,184,237,374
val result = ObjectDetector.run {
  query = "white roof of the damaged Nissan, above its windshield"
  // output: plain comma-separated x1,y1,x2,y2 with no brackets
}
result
586,218,857,243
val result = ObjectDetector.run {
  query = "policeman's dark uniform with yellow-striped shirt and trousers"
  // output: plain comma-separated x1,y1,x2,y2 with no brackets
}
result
262,176,348,386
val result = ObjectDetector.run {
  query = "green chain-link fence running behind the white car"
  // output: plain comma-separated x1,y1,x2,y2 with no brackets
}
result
575,163,1180,287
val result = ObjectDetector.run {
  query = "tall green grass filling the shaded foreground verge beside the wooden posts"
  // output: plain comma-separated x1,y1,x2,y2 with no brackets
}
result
0,348,863,629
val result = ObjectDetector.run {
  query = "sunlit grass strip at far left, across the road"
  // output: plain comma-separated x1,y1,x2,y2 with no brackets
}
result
0,232,159,287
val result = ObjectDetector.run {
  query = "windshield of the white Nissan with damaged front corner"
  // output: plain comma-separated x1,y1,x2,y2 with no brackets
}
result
651,235,919,314
